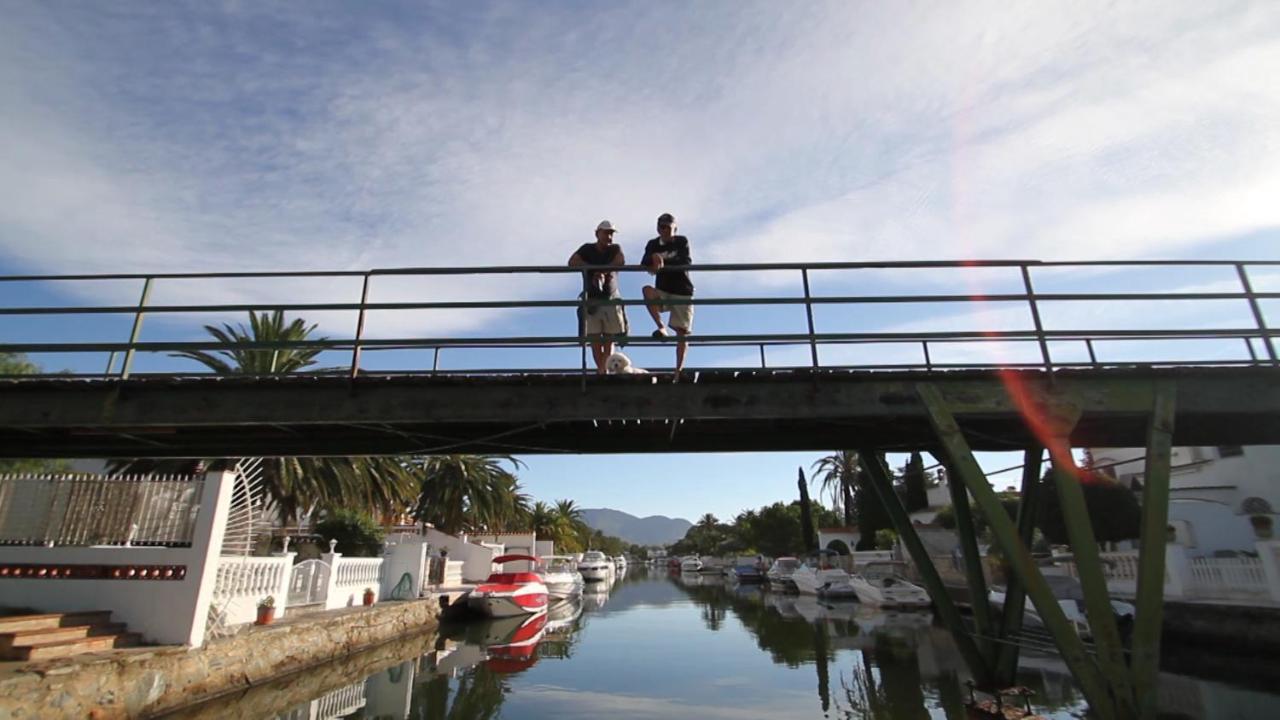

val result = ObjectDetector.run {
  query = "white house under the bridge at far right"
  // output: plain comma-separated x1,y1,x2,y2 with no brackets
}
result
1091,446,1280,557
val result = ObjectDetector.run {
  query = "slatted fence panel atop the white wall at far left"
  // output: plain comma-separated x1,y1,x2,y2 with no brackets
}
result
0,474,205,547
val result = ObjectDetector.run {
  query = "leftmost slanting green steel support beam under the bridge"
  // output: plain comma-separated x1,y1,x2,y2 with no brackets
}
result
858,448,992,687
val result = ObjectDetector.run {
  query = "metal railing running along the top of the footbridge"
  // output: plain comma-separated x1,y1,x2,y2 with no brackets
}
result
0,260,1280,379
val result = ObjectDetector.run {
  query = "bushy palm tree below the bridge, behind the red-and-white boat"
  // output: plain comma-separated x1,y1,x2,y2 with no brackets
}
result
413,455,529,534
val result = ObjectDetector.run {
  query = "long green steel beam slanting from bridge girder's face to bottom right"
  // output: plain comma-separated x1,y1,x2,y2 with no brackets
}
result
915,383,1120,720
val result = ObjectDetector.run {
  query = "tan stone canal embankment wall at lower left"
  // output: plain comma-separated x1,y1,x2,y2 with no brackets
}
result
0,600,439,720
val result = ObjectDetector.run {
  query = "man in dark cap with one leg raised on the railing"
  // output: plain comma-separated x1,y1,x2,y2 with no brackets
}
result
640,213,694,375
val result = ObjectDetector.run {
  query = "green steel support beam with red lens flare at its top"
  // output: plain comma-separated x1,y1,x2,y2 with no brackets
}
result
1050,450,1137,715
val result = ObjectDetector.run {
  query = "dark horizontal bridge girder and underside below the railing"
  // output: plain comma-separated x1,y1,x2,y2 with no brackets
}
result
0,368,1280,457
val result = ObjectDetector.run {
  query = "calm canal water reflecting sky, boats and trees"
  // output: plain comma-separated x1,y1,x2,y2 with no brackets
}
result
167,568,1280,720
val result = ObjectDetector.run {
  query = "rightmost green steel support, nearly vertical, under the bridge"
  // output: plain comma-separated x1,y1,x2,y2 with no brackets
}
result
1132,382,1176,717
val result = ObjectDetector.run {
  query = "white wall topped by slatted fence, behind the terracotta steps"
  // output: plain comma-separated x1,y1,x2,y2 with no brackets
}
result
0,473,234,646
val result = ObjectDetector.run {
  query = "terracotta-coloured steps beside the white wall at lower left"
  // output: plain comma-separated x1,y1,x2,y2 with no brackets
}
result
0,611,141,660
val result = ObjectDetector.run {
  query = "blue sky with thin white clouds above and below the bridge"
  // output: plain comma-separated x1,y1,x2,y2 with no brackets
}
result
0,0,1280,518
